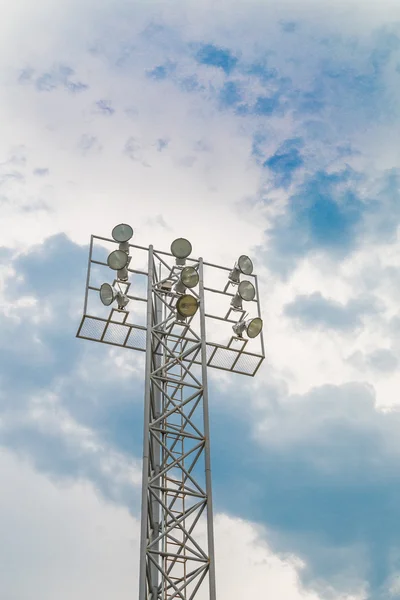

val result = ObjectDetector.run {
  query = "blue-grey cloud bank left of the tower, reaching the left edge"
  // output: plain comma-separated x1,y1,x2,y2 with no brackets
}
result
0,235,142,506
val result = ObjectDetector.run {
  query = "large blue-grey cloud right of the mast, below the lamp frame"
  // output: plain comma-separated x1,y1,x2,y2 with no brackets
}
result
212,382,400,600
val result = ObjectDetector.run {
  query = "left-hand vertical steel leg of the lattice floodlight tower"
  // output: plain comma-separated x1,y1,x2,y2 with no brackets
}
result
139,246,154,600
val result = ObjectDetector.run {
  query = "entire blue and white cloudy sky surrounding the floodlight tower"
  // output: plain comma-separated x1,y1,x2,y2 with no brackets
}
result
0,0,400,600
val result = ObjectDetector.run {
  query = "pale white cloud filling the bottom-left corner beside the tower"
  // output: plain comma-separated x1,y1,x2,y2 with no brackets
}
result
0,451,139,600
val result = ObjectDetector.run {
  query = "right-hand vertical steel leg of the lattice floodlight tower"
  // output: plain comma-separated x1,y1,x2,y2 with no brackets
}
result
199,258,216,600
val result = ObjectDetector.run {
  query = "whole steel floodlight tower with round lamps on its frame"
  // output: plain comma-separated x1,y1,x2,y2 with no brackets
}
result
77,224,265,600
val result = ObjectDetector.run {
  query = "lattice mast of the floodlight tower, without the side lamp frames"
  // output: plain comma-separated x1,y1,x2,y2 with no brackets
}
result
139,249,215,600
